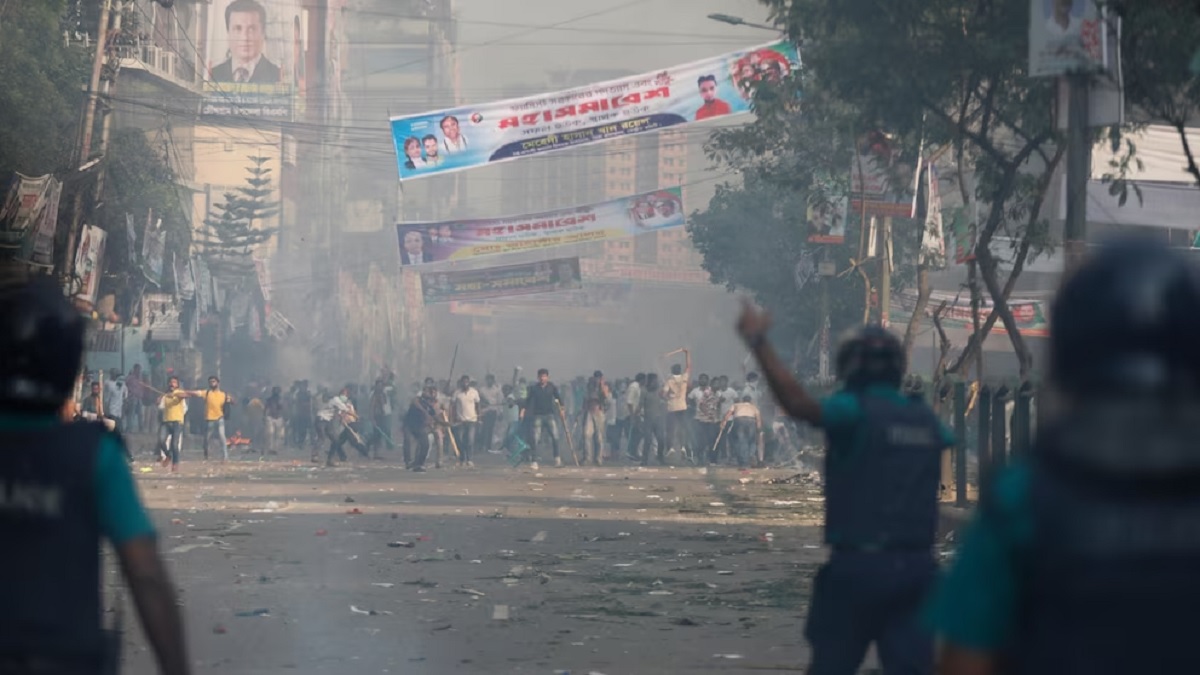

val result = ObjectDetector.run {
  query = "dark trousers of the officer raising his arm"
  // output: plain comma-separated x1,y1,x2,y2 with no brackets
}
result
804,550,937,675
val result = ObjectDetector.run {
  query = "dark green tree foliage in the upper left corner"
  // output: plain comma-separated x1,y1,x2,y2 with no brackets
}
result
0,0,90,178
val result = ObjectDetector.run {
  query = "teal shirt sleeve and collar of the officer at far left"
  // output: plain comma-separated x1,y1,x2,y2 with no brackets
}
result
0,414,155,545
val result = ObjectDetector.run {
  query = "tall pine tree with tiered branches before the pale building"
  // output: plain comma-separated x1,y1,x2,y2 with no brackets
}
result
196,156,280,281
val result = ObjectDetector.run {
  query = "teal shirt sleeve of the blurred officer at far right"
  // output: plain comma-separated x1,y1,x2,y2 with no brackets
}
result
924,460,1033,653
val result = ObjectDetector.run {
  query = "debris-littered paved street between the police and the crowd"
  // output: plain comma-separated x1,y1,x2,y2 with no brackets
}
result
113,441,844,675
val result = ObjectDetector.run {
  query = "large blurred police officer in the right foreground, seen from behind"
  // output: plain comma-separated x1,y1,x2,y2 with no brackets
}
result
928,239,1200,675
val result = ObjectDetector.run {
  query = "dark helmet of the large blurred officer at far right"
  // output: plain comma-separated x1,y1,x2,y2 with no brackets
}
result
1050,238,1200,396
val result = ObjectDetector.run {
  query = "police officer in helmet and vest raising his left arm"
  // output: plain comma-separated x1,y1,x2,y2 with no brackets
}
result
738,303,954,675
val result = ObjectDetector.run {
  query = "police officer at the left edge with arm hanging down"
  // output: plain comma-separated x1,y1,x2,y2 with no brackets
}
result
0,279,188,675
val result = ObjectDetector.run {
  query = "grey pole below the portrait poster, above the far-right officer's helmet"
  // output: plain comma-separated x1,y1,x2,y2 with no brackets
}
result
1062,73,1092,275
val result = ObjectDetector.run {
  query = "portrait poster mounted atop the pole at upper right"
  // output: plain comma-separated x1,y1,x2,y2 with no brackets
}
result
1030,0,1109,77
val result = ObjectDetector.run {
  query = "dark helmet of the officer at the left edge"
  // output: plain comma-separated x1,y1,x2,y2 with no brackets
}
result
0,279,86,410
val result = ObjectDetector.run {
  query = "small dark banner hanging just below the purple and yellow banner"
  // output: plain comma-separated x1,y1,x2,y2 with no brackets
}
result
421,258,583,305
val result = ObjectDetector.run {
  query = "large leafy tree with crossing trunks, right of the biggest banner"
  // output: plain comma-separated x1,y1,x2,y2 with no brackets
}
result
763,0,1062,372
